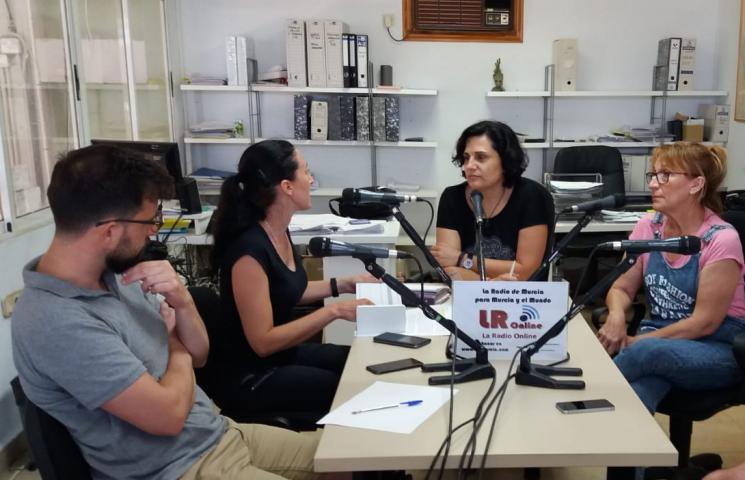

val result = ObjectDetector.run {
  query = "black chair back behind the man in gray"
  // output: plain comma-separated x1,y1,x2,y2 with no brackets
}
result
10,377,91,480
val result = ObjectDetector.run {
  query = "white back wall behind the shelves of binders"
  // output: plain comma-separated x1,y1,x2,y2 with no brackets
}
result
173,0,745,200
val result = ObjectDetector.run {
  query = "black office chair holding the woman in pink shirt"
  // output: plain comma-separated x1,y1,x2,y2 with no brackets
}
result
593,210,745,480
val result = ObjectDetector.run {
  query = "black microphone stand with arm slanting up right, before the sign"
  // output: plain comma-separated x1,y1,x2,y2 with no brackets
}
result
515,253,640,390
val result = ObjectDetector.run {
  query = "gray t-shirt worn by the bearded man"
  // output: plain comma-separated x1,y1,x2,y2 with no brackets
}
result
12,259,226,479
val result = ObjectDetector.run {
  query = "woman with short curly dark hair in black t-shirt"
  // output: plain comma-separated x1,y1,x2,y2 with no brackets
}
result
432,121,554,280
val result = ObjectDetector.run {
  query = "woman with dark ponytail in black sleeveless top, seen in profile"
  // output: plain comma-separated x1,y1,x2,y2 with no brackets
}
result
210,140,374,420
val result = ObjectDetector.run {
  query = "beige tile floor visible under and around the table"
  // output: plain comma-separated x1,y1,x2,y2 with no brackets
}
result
0,406,745,480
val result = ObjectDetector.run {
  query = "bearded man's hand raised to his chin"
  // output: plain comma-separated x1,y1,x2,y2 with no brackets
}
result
122,260,192,309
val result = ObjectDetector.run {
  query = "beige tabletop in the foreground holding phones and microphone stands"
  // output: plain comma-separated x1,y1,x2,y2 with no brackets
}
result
315,317,677,472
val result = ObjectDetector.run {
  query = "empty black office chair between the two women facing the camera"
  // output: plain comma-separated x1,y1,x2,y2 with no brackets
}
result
554,145,625,293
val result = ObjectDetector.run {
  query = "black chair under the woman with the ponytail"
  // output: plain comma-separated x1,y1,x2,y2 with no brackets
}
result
189,287,323,431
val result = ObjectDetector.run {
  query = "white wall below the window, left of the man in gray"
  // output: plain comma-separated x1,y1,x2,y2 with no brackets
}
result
0,225,54,449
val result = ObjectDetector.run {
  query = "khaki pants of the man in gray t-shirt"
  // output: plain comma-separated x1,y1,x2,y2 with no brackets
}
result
181,419,321,480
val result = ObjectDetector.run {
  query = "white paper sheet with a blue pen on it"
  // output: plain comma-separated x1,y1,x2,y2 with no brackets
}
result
318,382,458,433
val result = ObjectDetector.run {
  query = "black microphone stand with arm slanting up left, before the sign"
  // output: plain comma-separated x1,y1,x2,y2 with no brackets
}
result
352,255,497,385
